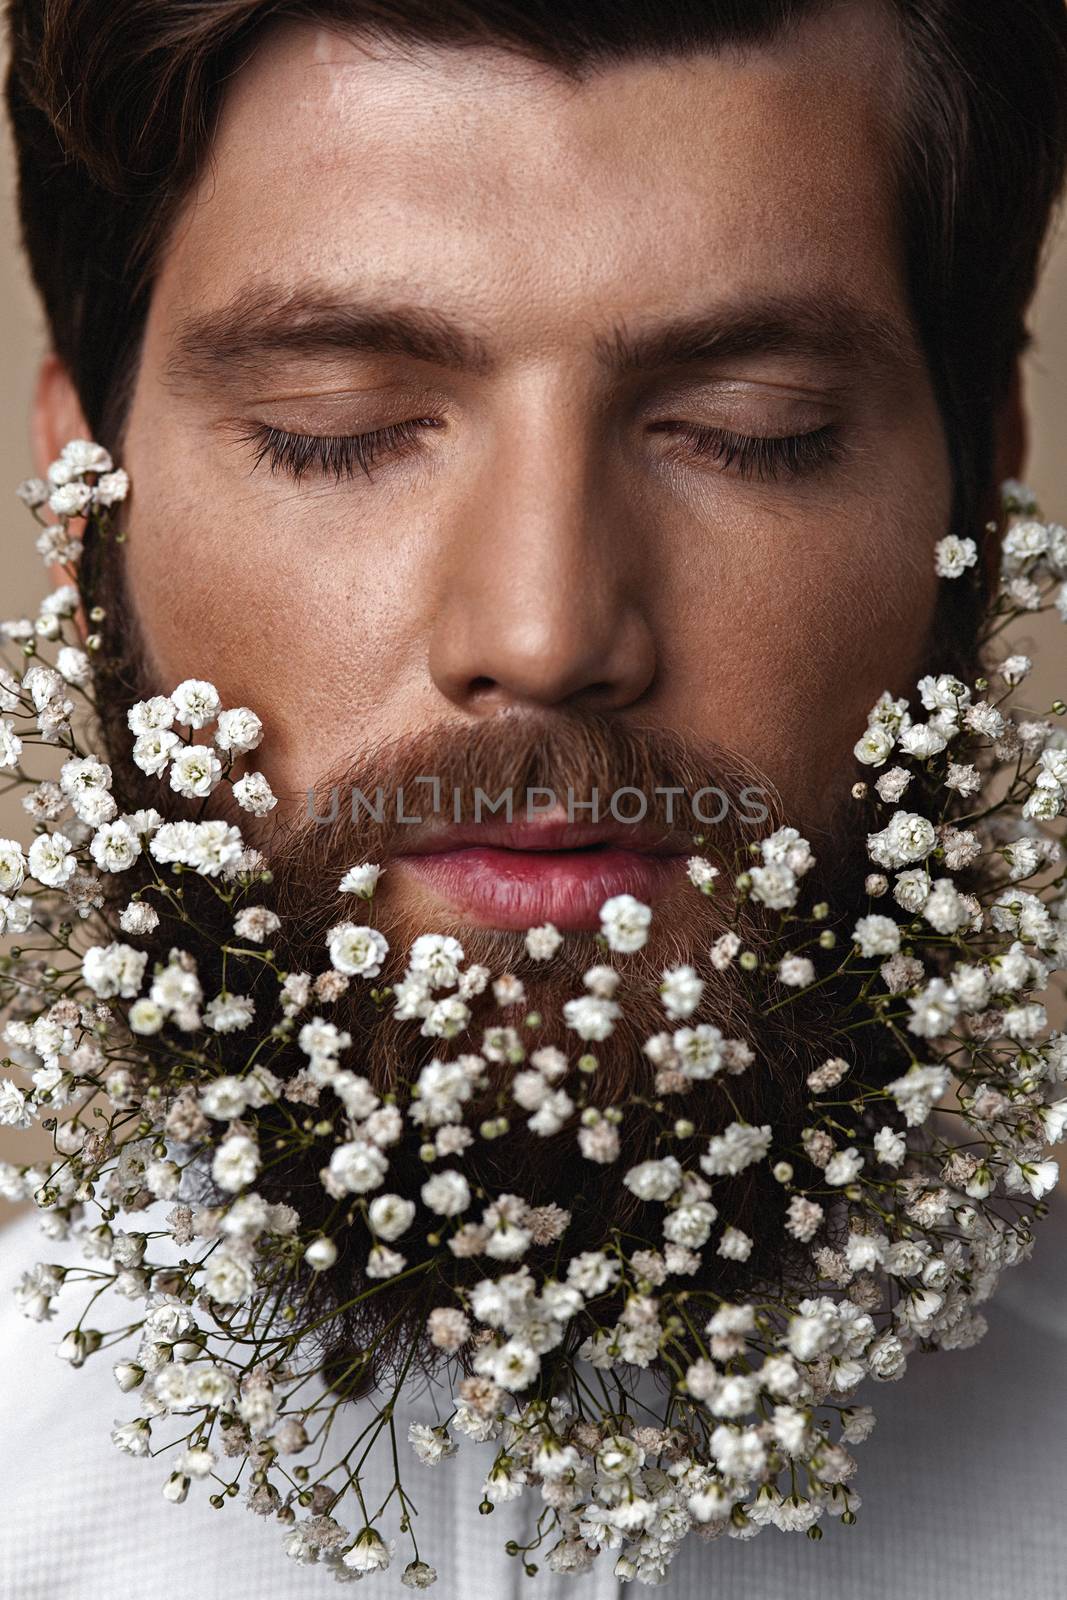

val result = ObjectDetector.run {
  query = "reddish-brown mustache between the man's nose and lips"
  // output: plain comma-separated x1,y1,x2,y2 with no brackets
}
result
247,710,782,968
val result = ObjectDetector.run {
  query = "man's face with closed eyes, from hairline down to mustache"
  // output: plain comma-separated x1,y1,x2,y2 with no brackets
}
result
115,3,950,925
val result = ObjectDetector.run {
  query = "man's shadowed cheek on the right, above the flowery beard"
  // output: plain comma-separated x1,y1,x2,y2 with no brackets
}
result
665,467,949,826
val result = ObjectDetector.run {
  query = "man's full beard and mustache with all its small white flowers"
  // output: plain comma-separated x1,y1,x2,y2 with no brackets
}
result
0,443,1067,1587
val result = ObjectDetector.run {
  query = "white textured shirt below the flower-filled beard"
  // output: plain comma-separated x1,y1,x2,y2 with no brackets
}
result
0,1205,1067,1600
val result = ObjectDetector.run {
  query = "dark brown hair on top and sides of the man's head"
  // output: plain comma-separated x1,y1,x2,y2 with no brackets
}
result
8,0,1067,531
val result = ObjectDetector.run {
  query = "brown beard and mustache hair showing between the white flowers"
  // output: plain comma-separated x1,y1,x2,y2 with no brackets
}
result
91,617,901,1397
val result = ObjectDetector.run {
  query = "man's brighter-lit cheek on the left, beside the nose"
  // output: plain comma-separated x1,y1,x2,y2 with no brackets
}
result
117,430,435,795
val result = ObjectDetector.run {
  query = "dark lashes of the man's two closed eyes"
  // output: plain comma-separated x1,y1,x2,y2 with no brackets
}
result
243,416,838,483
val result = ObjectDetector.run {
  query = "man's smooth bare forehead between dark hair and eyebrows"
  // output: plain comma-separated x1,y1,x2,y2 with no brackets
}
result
150,0,902,349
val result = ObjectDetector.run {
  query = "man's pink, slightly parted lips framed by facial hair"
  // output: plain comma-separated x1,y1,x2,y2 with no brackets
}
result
390,818,693,933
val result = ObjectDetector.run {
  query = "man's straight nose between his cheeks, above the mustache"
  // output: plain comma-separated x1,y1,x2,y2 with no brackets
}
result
429,390,656,715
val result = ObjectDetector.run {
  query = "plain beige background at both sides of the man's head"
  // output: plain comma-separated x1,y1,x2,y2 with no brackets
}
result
0,93,1067,1222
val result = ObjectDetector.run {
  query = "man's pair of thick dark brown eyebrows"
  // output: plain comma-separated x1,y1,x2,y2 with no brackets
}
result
166,285,917,386
